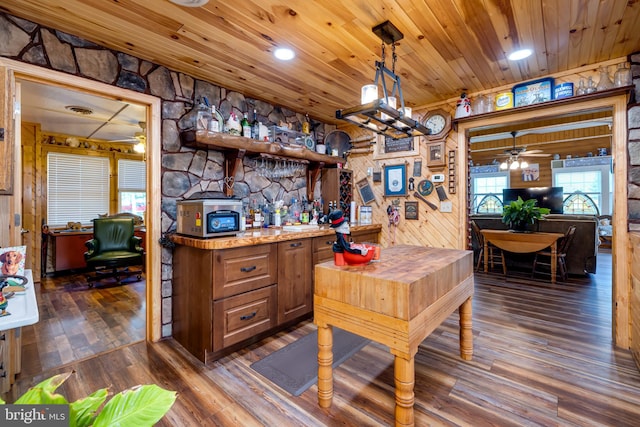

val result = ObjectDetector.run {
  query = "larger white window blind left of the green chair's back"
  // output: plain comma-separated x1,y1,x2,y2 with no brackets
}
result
47,153,109,226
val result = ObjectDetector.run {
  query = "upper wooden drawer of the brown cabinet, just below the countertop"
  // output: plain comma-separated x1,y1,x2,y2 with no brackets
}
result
213,244,278,300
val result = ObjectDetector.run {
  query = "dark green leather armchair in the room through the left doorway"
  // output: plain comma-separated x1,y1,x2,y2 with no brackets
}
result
84,218,145,287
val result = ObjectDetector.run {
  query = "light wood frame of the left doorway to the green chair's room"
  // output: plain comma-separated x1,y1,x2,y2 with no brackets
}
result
0,58,162,341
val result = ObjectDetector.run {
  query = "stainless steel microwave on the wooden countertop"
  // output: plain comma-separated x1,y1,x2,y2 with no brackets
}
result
176,199,244,238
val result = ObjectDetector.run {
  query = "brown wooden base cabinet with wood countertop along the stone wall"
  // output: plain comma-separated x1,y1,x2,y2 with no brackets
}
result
171,224,382,363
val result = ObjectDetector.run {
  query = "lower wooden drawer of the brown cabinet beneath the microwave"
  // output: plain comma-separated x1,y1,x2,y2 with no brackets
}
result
213,285,278,351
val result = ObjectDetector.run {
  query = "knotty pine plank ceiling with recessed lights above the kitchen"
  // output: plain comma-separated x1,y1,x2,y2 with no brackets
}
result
0,0,640,122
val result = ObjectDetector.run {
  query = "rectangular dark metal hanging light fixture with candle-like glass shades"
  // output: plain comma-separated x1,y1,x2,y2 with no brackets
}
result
336,21,430,139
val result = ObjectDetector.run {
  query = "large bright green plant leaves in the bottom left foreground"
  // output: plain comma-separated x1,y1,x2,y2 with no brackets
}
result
0,372,176,427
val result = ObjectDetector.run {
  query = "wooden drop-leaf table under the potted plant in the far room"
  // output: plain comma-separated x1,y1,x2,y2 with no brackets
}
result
480,229,564,283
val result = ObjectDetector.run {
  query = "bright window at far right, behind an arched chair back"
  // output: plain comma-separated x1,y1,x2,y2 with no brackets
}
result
552,158,613,215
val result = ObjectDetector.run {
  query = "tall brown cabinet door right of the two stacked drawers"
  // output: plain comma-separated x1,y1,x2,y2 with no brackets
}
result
278,239,313,324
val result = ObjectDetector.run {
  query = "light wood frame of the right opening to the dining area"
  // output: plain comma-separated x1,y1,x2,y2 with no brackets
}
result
457,92,631,349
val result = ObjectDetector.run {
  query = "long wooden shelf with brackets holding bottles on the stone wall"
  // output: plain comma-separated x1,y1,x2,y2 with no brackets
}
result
180,130,345,200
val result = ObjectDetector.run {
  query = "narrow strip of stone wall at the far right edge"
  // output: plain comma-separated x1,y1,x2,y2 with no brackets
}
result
627,53,640,231
